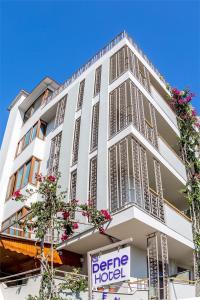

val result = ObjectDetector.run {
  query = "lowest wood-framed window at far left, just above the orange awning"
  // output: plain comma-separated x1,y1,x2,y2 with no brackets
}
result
2,207,30,238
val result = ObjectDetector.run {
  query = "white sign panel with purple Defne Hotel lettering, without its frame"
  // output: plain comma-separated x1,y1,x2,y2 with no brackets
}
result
92,247,130,287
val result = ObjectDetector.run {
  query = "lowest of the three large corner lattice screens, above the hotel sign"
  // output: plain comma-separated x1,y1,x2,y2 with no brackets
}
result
109,136,165,222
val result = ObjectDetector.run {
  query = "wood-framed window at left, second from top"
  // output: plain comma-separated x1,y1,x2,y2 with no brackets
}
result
16,120,47,156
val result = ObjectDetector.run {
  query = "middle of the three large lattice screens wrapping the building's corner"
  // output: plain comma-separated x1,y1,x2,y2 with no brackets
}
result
109,80,158,148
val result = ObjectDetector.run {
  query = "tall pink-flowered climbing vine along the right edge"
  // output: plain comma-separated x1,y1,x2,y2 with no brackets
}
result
170,88,200,282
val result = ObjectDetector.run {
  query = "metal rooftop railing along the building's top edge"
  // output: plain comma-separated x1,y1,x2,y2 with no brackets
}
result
44,31,167,106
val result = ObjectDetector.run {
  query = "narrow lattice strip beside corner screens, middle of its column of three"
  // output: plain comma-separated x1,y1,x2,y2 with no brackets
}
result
90,103,99,151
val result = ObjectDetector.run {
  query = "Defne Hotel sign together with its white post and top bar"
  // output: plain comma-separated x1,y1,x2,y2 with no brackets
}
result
87,238,133,300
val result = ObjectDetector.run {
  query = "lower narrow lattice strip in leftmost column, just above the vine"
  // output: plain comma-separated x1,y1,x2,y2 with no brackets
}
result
48,132,62,175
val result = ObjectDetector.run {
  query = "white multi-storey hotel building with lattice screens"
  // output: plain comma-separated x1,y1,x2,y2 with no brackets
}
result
0,32,194,299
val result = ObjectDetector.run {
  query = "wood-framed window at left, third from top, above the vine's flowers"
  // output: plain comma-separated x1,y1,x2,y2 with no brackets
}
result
6,156,40,200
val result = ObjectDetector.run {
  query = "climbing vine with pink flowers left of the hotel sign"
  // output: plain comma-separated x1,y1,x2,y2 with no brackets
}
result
13,175,111,300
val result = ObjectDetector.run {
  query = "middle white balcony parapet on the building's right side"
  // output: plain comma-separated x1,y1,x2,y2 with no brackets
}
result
158,136,187,180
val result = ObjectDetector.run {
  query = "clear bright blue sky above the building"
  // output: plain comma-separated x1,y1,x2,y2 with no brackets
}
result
0,0,200,144
